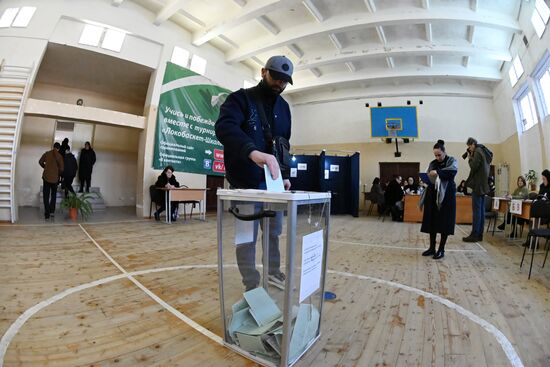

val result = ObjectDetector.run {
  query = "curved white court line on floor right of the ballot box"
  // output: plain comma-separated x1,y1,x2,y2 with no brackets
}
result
327,270,523,367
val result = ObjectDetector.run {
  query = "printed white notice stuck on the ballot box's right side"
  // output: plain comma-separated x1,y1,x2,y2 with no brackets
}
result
300,230,323,303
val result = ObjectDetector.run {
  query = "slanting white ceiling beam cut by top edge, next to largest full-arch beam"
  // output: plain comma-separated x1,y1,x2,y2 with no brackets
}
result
193,0,297,46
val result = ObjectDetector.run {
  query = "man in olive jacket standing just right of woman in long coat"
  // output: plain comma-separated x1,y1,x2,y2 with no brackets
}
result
462,138,493,242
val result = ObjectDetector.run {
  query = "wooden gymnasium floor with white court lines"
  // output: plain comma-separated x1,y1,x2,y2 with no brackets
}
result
0,216,550,367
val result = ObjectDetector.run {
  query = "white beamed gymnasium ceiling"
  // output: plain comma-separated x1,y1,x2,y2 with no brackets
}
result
118,0,522,103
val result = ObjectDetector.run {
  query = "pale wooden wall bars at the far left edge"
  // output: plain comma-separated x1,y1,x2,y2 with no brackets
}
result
0,61,33,223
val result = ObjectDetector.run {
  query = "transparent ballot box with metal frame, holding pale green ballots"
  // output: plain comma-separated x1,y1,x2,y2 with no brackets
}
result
217,190,330,367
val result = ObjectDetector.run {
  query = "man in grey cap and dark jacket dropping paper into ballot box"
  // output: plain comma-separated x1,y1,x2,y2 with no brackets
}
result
216,56,293,291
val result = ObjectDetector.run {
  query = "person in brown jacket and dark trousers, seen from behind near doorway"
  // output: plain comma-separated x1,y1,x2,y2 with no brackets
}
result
38,143,63,219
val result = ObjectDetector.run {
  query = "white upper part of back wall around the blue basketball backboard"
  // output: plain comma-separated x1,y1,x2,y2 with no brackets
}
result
291,97,499,145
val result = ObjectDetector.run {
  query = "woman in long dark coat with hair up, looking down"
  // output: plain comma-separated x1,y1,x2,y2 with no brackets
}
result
420,140,458,259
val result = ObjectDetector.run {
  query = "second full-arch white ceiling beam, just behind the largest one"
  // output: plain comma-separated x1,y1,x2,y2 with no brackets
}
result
294,43,512,70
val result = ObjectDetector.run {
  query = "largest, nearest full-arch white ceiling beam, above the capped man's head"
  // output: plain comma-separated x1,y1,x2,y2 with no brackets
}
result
226,8,521,63
